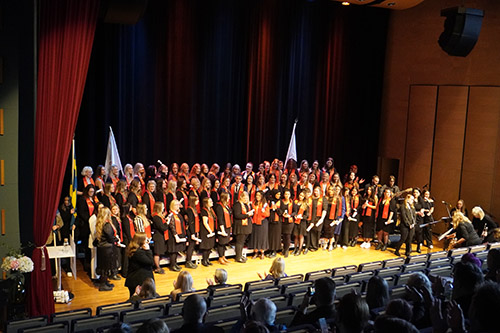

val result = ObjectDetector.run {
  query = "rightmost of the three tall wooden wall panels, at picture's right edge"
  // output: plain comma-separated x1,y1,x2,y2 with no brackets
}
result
461,87,500,211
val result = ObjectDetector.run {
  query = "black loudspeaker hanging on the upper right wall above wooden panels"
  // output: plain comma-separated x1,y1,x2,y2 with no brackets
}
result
438,7,484,57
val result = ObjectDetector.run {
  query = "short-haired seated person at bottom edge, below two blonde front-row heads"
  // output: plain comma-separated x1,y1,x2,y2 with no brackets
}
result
174,294,224,333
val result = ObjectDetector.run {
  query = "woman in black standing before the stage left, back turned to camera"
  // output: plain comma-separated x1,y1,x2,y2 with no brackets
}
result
125,233,154,297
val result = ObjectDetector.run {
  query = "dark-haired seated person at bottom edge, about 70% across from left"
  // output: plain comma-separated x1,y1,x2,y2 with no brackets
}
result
336,292,370,333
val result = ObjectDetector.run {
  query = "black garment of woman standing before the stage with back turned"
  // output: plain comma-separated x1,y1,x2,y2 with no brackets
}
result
125,248,154,289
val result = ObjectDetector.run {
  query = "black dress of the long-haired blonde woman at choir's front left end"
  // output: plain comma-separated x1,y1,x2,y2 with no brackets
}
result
96,222,118,276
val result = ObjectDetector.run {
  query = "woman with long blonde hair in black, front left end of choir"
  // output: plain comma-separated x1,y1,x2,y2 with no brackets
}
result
95,207,120,291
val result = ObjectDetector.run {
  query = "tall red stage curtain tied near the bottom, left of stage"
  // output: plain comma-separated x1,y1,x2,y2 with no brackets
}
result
29,0,99,316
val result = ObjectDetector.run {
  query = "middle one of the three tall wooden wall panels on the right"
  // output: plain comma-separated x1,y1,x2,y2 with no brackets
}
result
430,86,469,226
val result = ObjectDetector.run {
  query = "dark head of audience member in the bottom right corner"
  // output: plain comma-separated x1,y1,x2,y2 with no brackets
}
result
468,282,500,332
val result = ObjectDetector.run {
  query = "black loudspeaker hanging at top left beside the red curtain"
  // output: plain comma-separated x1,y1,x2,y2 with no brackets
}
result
101,0,148,24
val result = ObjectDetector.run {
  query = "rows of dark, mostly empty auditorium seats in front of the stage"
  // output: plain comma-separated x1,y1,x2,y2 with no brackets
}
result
6,243,500,333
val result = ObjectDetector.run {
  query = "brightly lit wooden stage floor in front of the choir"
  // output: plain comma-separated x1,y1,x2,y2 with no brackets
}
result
54,241,443,314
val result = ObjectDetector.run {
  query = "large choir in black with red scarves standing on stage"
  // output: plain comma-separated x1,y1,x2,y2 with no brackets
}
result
62,158,496,290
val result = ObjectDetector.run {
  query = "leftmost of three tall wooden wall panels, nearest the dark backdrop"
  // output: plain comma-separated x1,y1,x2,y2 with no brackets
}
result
402,86,437,188
